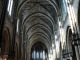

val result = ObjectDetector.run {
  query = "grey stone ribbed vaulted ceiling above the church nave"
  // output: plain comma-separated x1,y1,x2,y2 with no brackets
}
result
18,0,58,44
